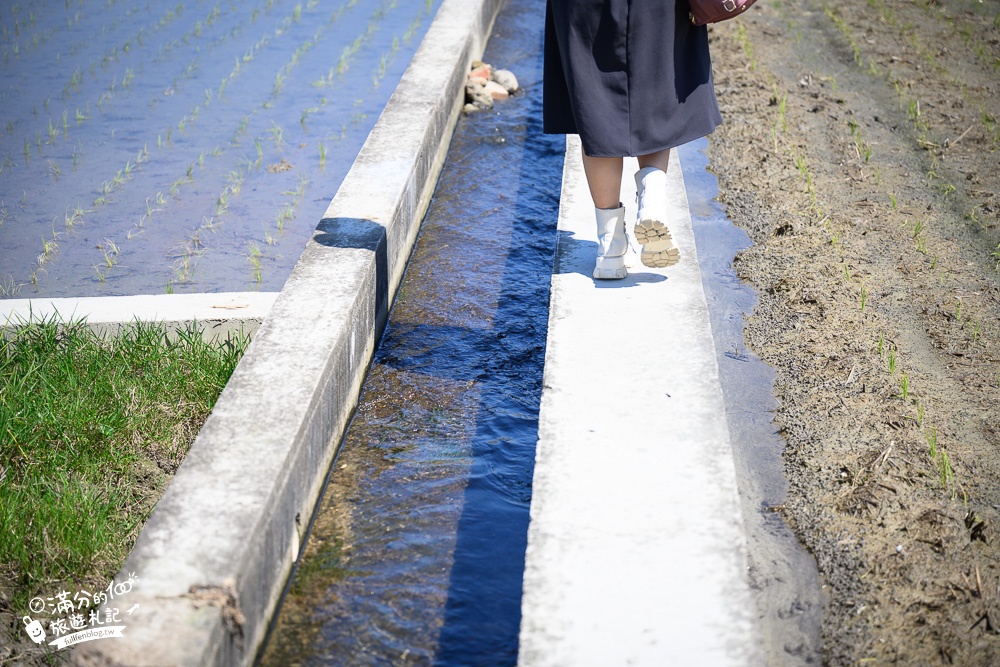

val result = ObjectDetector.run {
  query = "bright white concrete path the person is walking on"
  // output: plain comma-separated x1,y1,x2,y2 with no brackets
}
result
519,137,761,667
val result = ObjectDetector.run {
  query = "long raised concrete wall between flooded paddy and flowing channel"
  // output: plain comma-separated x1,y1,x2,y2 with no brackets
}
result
73,0,502,667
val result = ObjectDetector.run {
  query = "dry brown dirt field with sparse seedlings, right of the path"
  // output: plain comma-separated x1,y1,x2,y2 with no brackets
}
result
710,0,1000,665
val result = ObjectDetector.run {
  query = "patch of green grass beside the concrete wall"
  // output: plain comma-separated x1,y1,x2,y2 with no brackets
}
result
0,320,248,610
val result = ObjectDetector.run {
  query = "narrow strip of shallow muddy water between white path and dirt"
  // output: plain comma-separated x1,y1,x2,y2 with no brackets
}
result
680,139,824,665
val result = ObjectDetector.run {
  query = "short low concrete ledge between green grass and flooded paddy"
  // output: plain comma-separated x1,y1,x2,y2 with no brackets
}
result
0,292,278,340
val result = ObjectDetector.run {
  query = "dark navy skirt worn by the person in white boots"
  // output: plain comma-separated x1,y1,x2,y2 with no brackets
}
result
543,0,722,157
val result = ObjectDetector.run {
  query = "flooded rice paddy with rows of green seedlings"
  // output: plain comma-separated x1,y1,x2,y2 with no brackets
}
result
0,0,440,298
